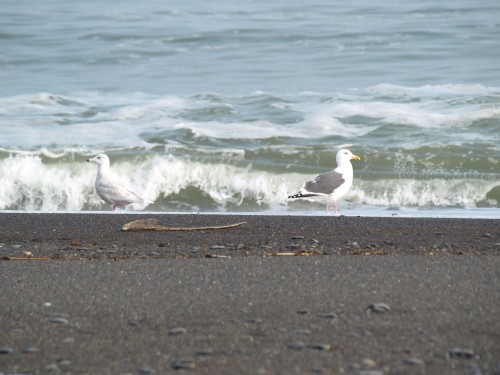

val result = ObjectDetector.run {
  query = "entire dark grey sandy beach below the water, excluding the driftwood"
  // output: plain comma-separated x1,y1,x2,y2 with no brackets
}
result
0,214,500,374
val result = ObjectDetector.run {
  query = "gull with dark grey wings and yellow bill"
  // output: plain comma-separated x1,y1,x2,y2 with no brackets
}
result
288,149,361,215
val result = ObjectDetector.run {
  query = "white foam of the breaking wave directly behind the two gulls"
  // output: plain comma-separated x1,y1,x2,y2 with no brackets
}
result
0,155,498,211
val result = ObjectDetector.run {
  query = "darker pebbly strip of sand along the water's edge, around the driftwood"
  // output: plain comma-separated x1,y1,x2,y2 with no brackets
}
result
0,213,500,259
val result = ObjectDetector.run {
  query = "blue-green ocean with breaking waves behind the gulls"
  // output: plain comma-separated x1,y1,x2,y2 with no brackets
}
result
0,0,500,218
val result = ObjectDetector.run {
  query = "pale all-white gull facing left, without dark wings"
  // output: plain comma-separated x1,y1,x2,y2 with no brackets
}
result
87,154,144,211
